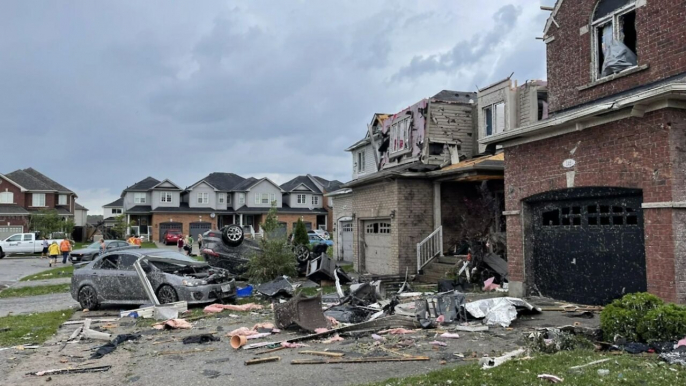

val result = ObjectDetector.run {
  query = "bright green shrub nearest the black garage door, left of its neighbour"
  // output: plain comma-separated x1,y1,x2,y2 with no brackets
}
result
600,292,664,342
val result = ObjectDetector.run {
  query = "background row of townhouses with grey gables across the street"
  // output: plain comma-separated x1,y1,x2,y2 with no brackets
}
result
103,172,342,240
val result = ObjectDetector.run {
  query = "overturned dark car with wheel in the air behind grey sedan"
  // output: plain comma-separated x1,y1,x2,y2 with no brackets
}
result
200,224,260,275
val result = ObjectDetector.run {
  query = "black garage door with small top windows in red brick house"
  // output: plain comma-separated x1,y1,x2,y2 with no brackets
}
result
532,188,647,305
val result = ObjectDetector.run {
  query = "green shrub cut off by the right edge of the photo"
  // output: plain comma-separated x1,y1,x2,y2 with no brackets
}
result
638,304,686,342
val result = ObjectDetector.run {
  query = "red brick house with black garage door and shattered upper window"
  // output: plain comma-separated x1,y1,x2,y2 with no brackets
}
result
480,0,686,304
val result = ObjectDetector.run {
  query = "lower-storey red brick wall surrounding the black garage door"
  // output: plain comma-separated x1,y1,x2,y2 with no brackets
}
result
505,108,686,301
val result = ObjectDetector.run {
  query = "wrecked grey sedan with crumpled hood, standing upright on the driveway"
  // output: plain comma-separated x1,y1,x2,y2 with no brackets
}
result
71,249,236,310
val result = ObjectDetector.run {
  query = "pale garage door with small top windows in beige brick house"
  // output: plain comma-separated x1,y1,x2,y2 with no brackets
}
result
363,221,397,275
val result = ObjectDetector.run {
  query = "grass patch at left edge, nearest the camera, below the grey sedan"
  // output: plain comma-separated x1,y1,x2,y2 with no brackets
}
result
0,310,74,347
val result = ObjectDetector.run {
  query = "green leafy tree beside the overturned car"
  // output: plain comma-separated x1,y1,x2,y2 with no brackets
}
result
247,203,298,283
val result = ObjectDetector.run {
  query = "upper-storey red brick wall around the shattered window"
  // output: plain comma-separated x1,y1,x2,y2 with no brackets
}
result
547,0,686,112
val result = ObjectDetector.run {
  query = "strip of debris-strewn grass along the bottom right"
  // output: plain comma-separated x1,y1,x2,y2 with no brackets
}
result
362,351,686,386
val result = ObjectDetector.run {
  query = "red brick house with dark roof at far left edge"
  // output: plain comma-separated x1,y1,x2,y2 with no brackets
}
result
0,168,88,240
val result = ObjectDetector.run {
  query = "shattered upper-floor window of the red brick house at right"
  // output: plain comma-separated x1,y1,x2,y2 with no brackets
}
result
593,0,638,79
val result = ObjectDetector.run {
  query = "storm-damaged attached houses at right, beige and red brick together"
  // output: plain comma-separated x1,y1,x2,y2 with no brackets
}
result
327,0,686,304
